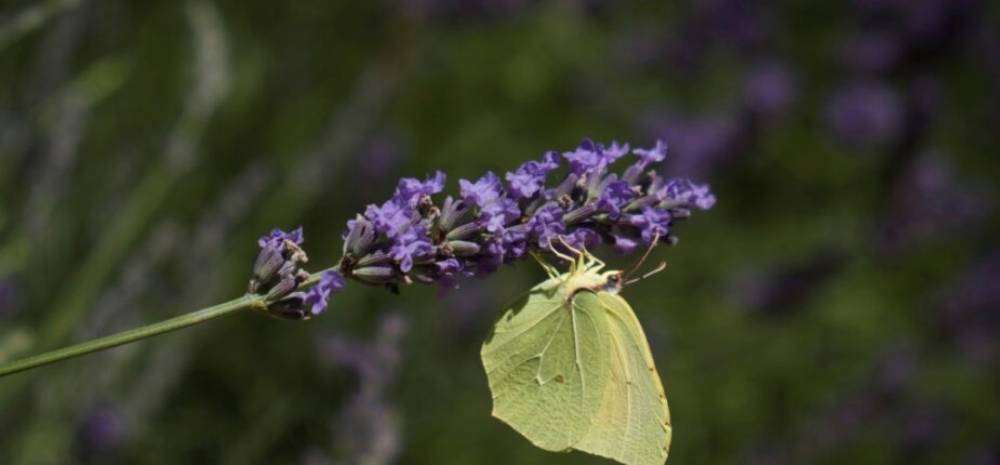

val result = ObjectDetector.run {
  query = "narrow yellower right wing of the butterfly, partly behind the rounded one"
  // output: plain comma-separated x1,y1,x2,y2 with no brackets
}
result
573,292,671,465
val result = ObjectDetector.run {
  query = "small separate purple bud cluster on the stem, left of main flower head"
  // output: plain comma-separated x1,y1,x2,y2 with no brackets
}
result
249,227,344,320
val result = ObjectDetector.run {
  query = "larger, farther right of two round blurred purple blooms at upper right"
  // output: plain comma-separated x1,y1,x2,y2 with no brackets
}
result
826,81,904,148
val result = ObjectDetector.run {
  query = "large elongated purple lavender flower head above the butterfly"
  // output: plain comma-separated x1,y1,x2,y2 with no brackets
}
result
340,140,715,290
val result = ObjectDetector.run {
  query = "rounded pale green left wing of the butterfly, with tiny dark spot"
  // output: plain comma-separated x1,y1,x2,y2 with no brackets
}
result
480,278,611,451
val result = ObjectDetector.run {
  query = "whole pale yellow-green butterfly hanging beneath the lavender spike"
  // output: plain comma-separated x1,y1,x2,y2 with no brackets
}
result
480,241,672,465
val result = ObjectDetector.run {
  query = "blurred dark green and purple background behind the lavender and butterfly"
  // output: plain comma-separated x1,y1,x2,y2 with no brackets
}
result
0,0,1000,465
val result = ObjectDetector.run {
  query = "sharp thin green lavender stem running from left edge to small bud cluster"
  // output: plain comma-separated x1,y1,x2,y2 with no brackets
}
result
0,295,264,377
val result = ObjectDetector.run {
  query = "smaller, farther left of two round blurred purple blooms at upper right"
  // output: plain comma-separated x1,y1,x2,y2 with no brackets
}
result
743,61,798,118
